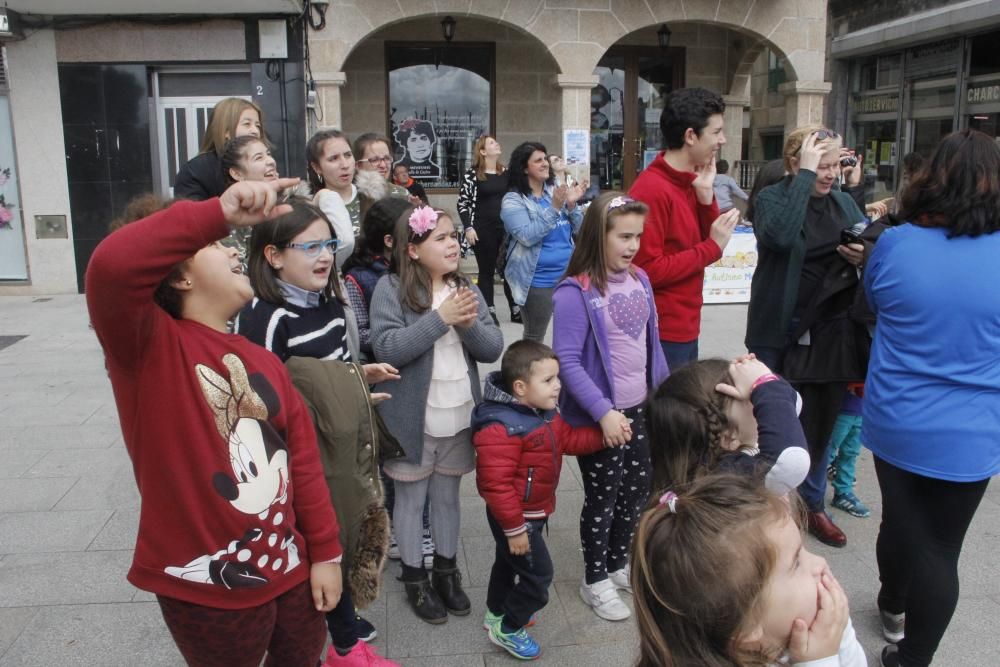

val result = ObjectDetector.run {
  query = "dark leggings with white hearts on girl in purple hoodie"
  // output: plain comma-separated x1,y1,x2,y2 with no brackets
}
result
577,406,653,584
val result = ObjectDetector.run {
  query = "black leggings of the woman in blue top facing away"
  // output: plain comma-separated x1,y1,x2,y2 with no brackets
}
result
875,456,990,667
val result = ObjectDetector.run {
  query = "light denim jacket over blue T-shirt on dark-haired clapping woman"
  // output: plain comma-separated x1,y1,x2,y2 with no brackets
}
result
500,185,583,306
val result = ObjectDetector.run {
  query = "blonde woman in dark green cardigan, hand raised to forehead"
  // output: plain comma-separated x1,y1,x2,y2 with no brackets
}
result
746,125,867,547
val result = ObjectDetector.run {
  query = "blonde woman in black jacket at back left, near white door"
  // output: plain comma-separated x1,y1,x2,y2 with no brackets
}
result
174,97,267,201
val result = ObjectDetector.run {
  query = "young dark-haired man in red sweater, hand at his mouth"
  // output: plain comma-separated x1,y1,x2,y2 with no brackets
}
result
629,88,740,370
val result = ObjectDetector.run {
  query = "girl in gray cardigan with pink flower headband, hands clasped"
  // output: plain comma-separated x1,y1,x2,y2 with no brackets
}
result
370,207,503,623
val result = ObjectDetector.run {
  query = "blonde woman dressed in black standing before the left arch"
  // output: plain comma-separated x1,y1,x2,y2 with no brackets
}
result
458,134,521,322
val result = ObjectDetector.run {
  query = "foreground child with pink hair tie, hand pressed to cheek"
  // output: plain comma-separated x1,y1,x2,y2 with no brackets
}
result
632,475,868,667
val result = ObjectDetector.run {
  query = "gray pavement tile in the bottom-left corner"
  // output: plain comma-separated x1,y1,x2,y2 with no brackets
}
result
0,602,184,667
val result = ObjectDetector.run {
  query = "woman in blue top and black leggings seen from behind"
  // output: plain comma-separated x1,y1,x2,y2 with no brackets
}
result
861,130,1000,667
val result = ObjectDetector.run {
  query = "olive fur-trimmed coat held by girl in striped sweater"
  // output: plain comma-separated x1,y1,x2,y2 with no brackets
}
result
287,357,402,609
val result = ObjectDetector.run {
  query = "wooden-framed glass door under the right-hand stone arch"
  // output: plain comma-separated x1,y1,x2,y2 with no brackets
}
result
590,47,684,190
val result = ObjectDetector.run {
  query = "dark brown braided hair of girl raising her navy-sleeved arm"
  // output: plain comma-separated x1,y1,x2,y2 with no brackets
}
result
646,359,733,489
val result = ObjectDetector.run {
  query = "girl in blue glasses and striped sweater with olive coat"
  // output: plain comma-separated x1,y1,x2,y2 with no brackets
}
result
236,198,399,665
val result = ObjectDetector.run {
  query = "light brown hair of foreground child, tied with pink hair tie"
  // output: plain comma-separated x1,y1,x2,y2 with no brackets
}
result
630,472,802,667
